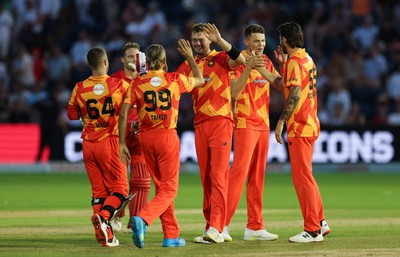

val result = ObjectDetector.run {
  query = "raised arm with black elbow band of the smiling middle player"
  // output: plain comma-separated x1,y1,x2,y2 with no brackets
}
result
204,23,246,67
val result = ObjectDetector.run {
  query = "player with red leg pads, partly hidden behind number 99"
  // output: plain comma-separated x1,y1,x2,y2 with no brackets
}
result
110,42,151,231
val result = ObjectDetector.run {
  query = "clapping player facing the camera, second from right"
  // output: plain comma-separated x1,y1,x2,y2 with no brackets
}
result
224,24,283,240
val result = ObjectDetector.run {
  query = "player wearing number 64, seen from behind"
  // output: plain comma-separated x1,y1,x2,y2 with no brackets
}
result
67,48,129,246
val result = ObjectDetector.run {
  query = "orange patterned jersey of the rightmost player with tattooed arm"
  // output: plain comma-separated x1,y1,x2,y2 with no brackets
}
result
283,49,320,137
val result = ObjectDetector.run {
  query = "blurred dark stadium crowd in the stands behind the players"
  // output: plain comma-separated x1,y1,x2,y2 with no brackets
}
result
0,0,400,131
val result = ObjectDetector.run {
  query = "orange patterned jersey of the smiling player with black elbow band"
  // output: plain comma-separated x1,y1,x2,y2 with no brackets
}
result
177,50,232,125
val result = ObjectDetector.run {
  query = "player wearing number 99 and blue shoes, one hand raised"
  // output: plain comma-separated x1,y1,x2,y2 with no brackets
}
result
119,40,204,248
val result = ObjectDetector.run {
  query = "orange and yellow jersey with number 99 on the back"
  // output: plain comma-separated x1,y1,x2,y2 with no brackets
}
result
124,70,195,132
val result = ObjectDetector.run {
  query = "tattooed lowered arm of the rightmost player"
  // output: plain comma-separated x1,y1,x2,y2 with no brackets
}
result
275,87,301,144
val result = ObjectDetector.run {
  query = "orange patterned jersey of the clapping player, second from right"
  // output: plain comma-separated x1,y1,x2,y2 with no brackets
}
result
231,51,280,130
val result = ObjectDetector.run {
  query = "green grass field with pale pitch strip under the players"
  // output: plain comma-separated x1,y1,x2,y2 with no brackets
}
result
0,170,400,257
